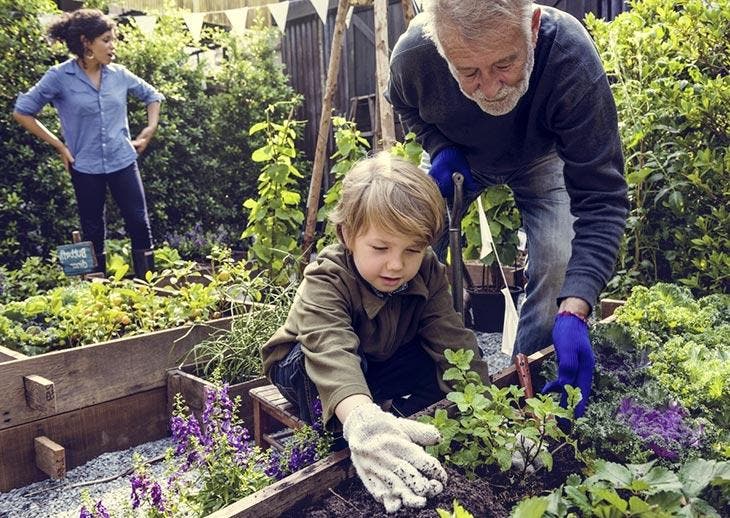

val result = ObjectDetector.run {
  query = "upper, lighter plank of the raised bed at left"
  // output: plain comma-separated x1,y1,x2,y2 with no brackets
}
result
0,318,232,430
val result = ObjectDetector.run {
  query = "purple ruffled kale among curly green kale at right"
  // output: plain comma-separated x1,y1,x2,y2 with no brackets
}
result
617,397,704,462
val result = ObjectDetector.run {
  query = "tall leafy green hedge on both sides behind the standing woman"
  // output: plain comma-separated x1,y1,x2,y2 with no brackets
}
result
0,0,296,266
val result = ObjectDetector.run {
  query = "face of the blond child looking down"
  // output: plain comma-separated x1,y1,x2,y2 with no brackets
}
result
343,226,426,292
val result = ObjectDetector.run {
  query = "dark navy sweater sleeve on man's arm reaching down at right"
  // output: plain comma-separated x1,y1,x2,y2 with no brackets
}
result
552,69,629,306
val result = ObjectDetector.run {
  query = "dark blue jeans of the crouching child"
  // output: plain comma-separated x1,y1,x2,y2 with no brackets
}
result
270,340,444,423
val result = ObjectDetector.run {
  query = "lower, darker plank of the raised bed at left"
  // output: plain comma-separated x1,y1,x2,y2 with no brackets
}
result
0,387,168,492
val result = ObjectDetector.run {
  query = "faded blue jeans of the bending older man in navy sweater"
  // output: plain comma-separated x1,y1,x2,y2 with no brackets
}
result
430,152,575,354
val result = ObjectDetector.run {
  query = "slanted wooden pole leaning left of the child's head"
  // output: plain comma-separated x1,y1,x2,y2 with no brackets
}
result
301,0,350,268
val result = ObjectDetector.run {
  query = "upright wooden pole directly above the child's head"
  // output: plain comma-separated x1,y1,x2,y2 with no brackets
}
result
373,0,395,150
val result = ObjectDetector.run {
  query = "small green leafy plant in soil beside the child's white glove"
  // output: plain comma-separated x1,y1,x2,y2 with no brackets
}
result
421,349,580,478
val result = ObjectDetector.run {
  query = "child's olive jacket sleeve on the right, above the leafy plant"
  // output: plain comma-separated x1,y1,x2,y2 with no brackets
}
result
419,256,490,392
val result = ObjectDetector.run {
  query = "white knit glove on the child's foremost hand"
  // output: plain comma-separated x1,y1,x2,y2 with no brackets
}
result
342,403,447,513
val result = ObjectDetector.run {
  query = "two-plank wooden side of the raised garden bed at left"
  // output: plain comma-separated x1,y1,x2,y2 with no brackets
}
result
0,318,232,491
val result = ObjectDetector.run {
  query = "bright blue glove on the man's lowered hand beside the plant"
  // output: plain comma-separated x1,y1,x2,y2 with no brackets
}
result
542,313,596,417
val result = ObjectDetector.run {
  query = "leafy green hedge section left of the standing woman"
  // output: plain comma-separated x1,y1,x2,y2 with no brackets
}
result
0,0,78,267
